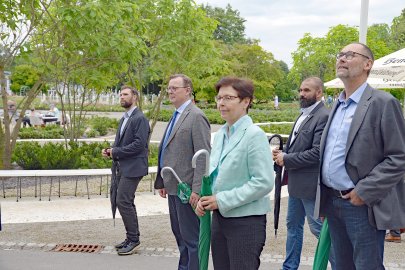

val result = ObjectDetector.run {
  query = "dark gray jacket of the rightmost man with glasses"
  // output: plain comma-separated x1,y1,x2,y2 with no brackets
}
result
314,85,405,230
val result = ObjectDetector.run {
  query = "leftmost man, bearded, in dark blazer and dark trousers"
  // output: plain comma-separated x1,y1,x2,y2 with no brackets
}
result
102,86,149,255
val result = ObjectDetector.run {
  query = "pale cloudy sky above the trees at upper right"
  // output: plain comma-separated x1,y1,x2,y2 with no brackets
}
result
196,0,405,67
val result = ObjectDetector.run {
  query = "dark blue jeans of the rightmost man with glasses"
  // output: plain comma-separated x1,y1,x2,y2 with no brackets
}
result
326,196,385,270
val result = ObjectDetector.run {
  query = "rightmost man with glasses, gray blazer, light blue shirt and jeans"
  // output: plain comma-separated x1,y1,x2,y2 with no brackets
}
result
314,43,405,270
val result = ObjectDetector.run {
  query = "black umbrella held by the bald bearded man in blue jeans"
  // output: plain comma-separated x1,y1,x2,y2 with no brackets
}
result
269,134,283,237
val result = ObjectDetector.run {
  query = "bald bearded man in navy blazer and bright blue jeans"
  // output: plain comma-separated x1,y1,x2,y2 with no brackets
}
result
273,77,333,270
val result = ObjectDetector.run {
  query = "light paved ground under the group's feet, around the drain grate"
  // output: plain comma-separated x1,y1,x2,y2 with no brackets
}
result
0,189,405,270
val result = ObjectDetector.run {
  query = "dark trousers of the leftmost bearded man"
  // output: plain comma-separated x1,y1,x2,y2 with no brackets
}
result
117,176,142,242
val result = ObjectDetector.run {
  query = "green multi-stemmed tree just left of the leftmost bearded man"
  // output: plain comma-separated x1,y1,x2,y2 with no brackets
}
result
32,0,146,142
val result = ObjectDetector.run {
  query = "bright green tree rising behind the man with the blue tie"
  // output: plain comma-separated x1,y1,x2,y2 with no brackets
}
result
123,0,221,141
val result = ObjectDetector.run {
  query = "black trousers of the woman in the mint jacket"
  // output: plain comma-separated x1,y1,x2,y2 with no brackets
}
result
211,210,267,270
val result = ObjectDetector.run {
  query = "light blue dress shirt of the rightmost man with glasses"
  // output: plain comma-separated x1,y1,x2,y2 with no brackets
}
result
322,82,367,190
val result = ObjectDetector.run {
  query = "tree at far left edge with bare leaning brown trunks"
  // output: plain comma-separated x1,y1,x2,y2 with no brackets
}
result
0,0,48,169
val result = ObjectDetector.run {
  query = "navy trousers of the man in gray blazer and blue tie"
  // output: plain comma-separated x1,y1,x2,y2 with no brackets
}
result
168,195,200,270
